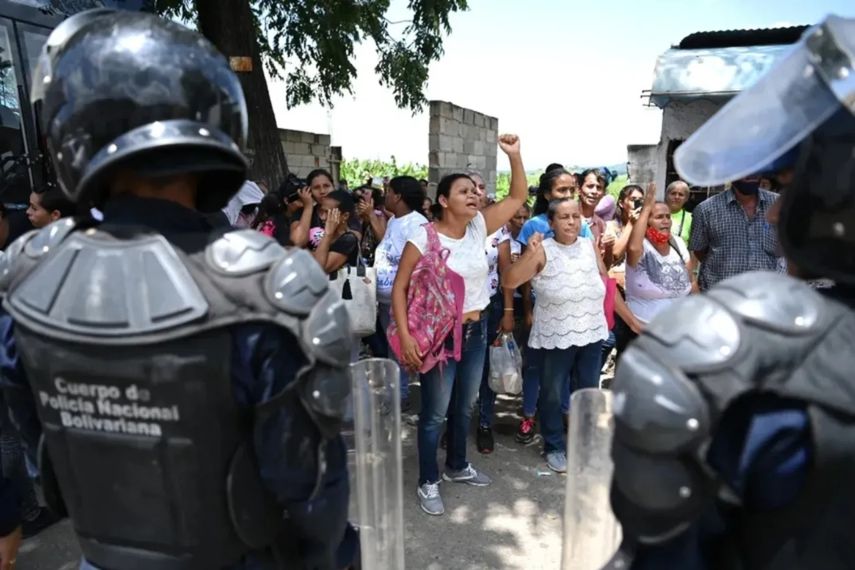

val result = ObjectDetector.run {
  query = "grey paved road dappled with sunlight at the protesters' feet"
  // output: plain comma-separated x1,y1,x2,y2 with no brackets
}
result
18,382,566,570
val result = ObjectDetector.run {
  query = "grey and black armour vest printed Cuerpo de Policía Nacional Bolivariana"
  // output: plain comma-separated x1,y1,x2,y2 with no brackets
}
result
0,219,351,570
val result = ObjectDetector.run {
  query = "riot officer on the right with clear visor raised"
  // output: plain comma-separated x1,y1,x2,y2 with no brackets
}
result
609,16,855,570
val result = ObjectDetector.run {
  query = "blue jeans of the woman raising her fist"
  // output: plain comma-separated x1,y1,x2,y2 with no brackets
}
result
418,313,487,485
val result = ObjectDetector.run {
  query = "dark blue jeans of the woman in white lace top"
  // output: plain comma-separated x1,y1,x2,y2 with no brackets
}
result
538,341,603,453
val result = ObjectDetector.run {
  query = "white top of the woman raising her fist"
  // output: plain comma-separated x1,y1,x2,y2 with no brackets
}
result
409,212,490,313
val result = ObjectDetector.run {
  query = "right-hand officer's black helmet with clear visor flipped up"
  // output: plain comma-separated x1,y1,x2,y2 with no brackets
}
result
674,16,855,285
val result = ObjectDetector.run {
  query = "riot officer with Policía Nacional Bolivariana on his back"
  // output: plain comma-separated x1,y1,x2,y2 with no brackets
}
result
0,10,351,570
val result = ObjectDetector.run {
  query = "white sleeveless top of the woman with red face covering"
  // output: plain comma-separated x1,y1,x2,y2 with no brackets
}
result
626,235,692,323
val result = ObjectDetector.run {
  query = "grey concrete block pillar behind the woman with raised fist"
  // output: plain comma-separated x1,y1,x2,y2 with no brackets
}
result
428,101,499,193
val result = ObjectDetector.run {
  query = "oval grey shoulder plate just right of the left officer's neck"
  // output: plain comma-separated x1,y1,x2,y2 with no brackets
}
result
205,230,285,277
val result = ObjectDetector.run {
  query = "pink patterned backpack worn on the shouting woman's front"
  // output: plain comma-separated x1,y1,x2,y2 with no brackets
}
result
386,224,465,374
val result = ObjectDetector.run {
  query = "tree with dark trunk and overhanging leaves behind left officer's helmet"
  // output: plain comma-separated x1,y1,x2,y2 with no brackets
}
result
155,0,467,190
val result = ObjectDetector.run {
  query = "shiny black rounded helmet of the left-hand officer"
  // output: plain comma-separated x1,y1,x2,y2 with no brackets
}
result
32,9,248,212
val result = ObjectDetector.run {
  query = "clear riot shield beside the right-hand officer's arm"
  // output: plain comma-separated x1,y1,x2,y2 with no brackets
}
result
561,388,621,570
